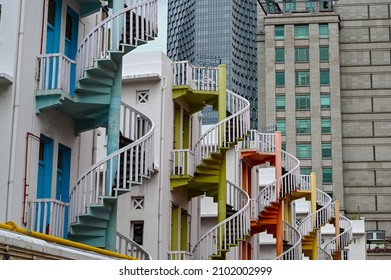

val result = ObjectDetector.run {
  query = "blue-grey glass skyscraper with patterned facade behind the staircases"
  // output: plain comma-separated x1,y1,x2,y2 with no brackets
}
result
167,0,258,128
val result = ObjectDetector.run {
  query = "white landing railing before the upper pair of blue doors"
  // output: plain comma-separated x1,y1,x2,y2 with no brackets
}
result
37,53,76,93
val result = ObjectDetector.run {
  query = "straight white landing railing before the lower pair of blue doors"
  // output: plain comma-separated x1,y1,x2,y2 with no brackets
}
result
27,198,69,238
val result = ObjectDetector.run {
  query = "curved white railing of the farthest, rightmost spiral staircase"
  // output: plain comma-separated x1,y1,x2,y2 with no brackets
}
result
323,204,353,255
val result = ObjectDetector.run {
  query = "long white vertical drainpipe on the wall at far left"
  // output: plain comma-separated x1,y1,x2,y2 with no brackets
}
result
5,0,25,221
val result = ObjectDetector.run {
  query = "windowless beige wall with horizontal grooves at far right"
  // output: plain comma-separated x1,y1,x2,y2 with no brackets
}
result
338,0,391,235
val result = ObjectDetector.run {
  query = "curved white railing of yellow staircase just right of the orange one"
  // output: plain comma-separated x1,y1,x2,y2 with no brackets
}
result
297,189,332,236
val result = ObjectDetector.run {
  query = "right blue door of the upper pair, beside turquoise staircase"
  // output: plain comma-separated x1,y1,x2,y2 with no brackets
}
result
65,7,79,96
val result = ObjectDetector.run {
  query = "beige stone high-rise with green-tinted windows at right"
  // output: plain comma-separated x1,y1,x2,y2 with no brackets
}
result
257,0,391,235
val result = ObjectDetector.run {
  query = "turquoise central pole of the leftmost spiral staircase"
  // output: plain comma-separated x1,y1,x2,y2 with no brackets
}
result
106,0,124,251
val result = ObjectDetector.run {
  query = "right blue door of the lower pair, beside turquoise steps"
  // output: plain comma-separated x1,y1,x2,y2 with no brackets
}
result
56,144,71,236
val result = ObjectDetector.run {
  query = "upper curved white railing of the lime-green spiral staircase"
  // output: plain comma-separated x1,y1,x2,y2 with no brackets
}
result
193,90,250,166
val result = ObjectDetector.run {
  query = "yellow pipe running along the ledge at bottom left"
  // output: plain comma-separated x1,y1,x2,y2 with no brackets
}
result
0,221,138,260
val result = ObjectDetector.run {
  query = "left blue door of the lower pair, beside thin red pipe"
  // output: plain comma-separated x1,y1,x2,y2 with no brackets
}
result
34,134,53,233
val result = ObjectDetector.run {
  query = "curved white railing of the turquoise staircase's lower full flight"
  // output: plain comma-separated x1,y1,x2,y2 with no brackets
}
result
69,103,155,223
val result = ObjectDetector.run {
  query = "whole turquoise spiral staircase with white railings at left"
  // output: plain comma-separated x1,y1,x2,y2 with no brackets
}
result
36,0,158,254
